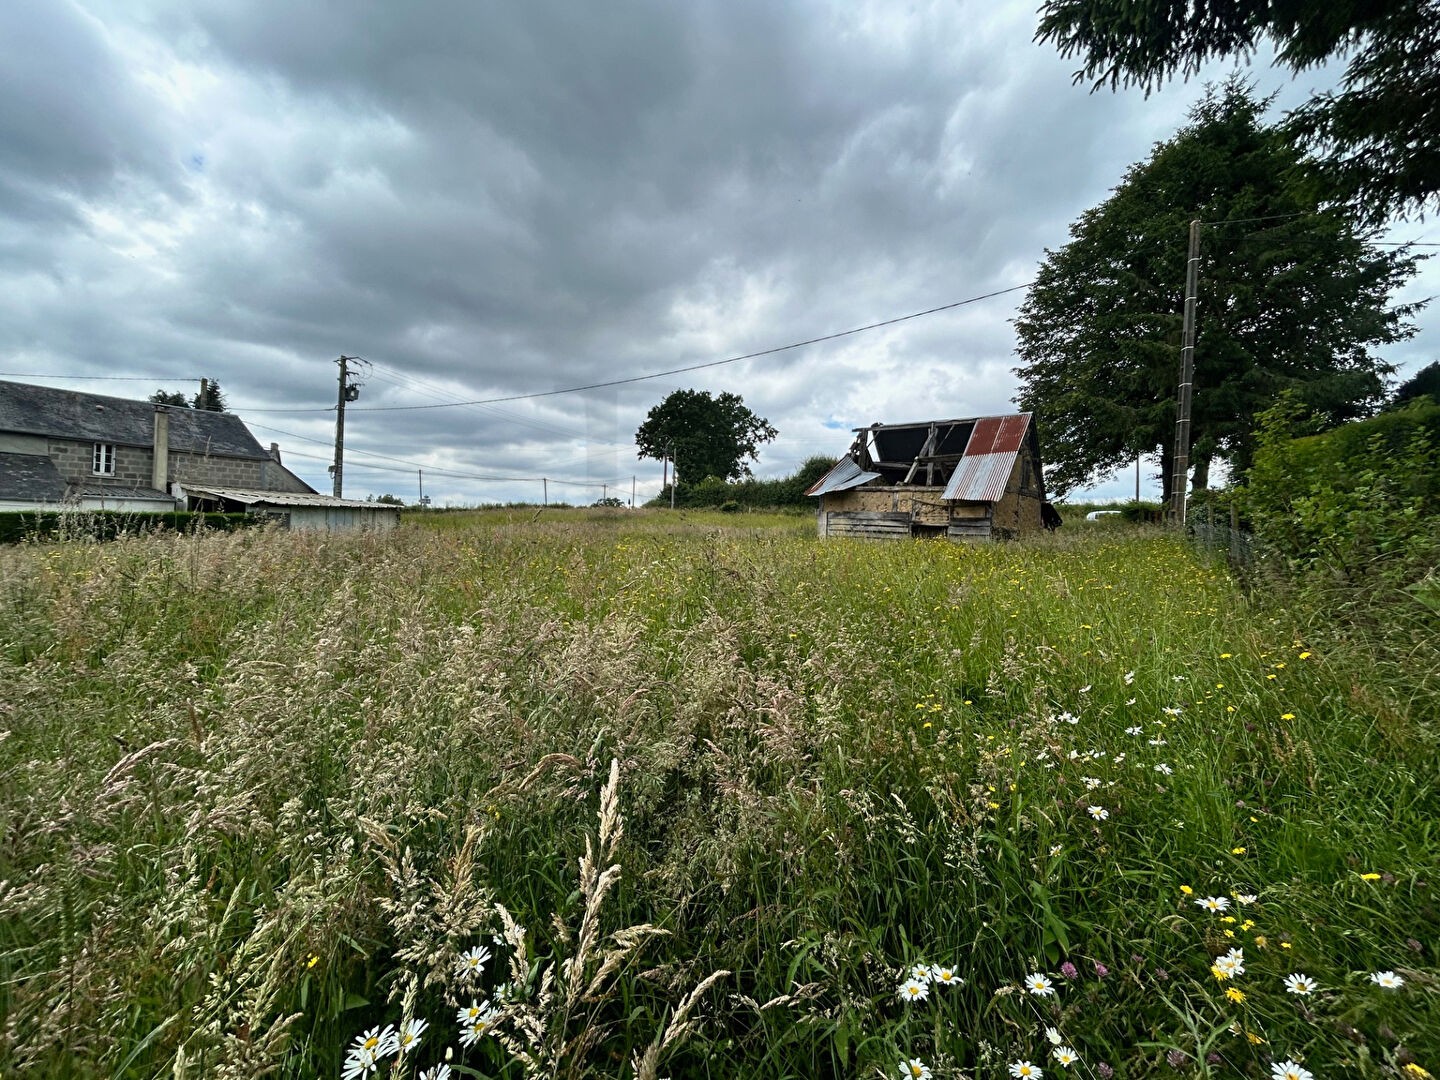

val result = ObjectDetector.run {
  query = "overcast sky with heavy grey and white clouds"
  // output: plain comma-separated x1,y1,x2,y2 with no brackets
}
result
0,0,1440,504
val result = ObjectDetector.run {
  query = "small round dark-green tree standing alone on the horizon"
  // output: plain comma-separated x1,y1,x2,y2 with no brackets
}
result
635,390,779,484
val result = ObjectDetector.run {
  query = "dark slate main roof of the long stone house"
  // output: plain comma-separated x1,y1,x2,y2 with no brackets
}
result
0,382,269,461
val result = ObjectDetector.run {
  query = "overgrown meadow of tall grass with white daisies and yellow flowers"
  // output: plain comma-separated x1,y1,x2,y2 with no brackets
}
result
0,511,1440,1080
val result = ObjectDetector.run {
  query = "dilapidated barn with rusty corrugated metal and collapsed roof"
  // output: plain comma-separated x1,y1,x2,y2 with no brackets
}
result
805,412,1058,540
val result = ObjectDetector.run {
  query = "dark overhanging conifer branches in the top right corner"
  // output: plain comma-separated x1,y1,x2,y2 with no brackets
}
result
1035,0,1440,223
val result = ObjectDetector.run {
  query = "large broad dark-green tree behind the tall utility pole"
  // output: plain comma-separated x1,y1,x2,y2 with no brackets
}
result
1015,79,1418,504
